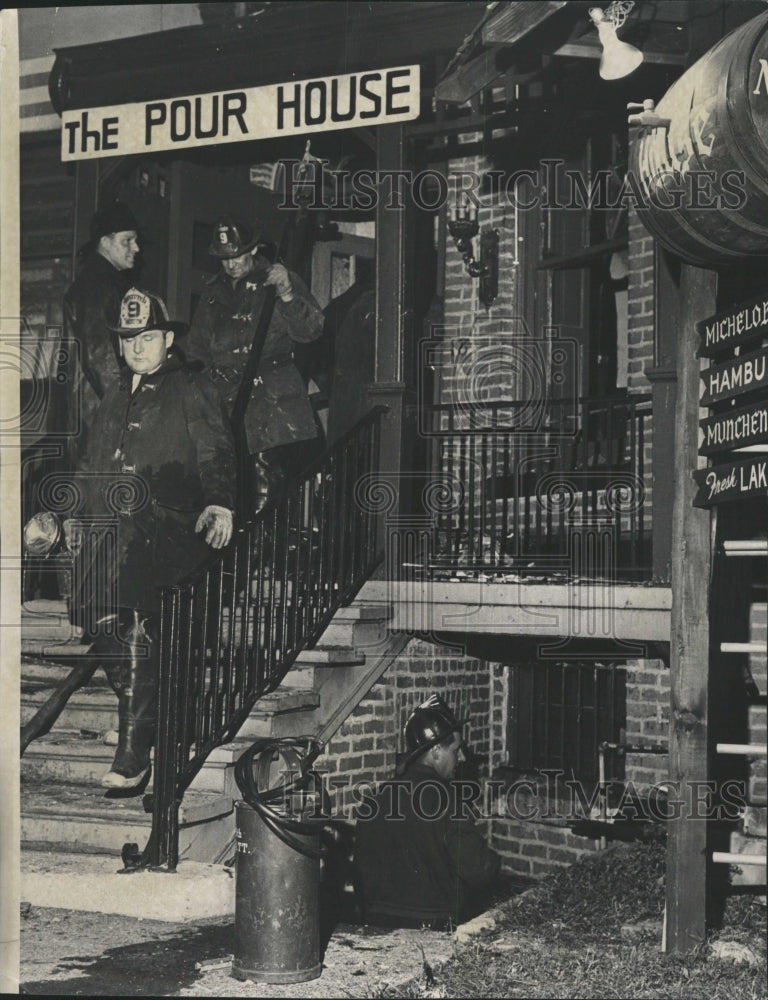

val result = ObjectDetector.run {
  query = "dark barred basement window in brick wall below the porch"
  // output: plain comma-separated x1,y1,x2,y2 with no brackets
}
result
507,660,626,781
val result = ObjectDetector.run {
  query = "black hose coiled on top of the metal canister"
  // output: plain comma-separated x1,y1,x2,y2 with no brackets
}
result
235,736,325,860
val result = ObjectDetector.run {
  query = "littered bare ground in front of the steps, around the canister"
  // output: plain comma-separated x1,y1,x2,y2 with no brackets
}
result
20,907,454,997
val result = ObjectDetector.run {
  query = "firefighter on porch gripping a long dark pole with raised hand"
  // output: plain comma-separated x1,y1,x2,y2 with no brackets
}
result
184,218,323,511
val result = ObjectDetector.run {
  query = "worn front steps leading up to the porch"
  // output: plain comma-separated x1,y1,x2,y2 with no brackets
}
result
21,601,407,864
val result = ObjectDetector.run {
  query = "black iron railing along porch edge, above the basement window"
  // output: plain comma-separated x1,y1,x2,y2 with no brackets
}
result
422,395,651,580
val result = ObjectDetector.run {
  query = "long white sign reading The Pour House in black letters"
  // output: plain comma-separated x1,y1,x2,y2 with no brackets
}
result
61,65,420,162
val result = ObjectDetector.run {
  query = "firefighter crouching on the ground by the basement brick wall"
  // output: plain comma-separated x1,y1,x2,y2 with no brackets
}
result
355,695,500,927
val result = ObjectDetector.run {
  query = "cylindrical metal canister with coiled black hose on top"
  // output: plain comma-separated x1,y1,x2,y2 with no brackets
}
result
232,737,324,983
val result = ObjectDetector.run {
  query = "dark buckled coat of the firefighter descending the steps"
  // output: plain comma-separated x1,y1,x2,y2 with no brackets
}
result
78,353,235,612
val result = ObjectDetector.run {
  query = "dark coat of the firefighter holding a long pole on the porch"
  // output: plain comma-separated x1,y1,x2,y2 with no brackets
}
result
184,271,323,454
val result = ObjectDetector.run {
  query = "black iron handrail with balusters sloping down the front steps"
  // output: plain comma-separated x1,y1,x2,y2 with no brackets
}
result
140,407,384,870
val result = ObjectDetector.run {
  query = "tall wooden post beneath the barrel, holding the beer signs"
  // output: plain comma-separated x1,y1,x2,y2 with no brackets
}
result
666,264,717,954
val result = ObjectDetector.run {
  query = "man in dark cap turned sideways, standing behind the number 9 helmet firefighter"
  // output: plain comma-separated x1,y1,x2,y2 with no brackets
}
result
64,201,139,450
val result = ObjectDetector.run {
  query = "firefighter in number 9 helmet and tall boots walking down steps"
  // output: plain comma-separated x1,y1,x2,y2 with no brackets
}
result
75,288,235,795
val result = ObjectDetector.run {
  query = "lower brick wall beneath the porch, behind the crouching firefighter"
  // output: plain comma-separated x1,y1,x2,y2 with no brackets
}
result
328,639,669,876
